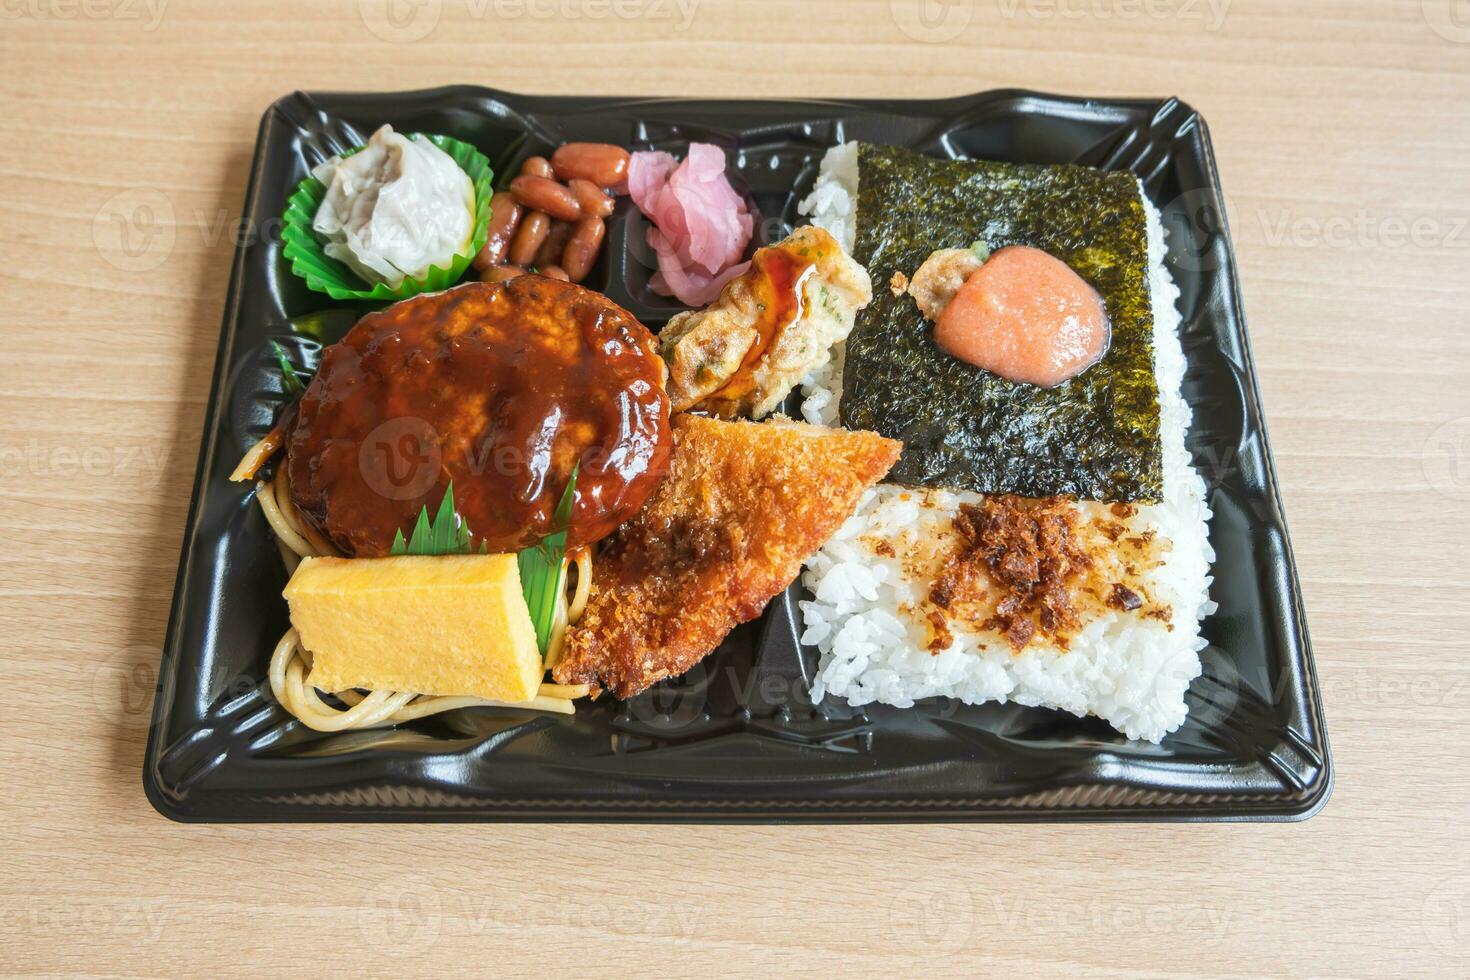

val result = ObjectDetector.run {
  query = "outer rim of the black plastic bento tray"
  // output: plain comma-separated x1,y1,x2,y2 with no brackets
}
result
141,84,1336,824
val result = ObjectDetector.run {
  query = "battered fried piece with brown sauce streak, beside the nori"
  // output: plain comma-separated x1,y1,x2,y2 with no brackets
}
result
659,226,873,419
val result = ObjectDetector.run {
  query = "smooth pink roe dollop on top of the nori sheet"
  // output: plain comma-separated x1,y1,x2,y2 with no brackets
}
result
933,245,1111,388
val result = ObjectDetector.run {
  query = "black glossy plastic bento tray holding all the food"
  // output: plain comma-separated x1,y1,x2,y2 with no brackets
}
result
144,87,1332,821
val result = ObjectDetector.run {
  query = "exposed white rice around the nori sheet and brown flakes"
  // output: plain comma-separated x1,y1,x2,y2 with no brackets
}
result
800,144,1214,742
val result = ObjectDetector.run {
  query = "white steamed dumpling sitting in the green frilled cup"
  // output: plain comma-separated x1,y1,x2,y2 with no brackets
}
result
312,126,475,288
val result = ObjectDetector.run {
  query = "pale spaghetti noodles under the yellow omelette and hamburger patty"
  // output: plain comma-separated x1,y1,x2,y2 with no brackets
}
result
231,435,592,732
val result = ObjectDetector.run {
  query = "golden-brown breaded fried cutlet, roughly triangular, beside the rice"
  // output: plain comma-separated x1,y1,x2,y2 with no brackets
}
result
553,416,903,698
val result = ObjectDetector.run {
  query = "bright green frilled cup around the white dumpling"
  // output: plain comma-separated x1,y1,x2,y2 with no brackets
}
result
281,132,495,301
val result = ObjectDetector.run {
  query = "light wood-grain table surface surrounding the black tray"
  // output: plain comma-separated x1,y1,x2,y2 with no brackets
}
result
0,0,1470,977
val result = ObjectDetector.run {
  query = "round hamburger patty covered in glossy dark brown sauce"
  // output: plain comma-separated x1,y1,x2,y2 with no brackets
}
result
288,275,672,555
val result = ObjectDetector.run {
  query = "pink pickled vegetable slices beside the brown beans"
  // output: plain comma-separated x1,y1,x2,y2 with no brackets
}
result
628,143,756,306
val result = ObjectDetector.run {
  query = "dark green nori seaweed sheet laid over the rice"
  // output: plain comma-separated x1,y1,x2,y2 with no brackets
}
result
841,143,1163,501
